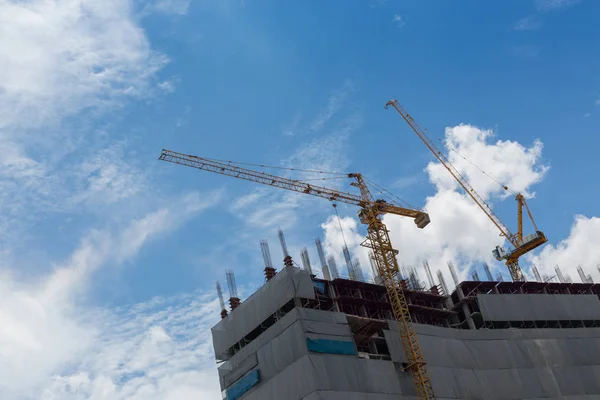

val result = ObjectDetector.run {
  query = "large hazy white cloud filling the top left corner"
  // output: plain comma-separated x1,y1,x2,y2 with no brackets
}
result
0,0,166,134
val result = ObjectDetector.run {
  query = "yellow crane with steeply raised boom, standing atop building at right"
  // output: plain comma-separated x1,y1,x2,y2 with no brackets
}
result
385,100,548,282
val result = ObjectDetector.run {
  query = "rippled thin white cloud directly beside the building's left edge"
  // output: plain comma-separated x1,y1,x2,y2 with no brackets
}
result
41,292,220,400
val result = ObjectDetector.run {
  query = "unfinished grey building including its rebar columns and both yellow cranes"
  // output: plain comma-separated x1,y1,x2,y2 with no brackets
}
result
159,104,600,400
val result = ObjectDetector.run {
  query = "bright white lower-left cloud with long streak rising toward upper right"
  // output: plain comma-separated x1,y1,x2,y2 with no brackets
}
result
0,193,219,400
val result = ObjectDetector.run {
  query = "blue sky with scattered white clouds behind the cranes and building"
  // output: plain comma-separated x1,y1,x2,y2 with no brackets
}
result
0,0,600,399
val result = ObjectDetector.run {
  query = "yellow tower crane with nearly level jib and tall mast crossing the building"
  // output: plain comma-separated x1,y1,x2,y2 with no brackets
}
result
159,149,435,400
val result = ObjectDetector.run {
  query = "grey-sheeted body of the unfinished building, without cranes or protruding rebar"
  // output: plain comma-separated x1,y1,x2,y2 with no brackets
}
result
212,267,600,400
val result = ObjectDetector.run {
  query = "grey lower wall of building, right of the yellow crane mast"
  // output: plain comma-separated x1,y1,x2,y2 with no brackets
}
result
386,324,600,400
